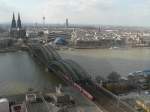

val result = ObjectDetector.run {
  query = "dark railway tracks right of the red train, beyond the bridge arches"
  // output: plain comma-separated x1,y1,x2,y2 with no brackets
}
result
82,85,135,112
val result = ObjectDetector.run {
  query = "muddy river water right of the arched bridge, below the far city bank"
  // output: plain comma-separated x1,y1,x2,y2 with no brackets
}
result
59,48,150,78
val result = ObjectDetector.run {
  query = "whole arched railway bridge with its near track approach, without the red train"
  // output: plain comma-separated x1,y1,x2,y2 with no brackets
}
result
29,44,135,112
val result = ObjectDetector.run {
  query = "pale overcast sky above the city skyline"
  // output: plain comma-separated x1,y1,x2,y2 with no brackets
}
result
0,0,150,26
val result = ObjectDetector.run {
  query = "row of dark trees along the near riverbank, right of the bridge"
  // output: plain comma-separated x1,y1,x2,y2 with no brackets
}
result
96,72,150,94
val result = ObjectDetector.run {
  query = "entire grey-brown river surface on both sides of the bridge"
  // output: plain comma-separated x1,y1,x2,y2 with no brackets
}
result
0,48,150,95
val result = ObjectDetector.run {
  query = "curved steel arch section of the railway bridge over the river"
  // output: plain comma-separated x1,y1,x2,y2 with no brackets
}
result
29,44,90,83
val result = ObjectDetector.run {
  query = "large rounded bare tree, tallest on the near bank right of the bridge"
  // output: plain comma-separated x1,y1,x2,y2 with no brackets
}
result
107,71,121,82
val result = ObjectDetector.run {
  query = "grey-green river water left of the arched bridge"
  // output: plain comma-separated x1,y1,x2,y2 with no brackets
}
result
0,51,62,95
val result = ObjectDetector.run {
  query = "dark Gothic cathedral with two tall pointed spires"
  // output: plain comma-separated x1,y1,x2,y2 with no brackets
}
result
10,13,26,39
